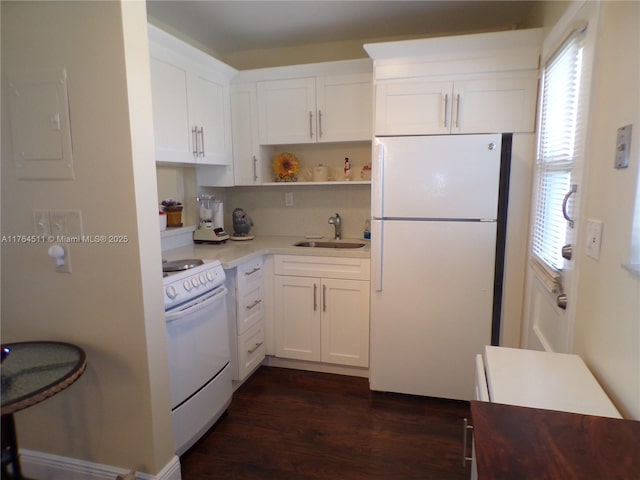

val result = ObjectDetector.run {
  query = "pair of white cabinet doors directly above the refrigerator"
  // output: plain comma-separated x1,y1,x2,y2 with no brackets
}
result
375,71,538,135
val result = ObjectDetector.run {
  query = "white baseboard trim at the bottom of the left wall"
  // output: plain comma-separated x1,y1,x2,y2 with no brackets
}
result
20,448,182,480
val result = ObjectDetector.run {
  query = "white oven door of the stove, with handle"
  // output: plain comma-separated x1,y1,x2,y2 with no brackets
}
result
165,287,230,410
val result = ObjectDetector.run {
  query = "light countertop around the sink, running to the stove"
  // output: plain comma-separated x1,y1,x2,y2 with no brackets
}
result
162,236,370,269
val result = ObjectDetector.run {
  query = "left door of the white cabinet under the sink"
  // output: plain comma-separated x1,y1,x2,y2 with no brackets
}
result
274,275,321,362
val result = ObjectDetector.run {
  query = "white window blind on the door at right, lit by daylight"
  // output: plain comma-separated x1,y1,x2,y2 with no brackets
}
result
532,30,584,272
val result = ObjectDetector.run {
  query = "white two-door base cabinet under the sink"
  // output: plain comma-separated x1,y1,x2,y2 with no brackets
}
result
274,255,369,367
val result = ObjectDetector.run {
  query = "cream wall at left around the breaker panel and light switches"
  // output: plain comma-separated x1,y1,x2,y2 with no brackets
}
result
2,2,173,473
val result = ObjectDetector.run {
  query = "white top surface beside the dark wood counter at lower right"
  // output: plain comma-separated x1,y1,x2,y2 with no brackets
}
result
484,346,622,418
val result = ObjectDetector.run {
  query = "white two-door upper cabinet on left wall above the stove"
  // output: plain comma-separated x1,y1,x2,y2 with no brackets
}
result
149,26,235,165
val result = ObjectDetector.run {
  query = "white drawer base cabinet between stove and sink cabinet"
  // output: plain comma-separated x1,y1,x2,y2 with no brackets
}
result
226,257,265,381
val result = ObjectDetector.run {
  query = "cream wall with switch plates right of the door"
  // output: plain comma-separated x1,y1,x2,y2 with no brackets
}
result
574,1,640,420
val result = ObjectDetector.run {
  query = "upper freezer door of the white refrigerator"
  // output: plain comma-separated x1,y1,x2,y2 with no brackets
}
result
371,135,501,219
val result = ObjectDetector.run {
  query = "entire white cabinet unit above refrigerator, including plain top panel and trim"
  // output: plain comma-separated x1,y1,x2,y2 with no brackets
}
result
365,29,541,136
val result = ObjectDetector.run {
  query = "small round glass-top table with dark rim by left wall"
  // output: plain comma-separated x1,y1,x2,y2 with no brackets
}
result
0,342,87,479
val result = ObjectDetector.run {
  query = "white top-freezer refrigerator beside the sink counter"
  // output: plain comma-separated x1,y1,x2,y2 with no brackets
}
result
369,134,502,400
